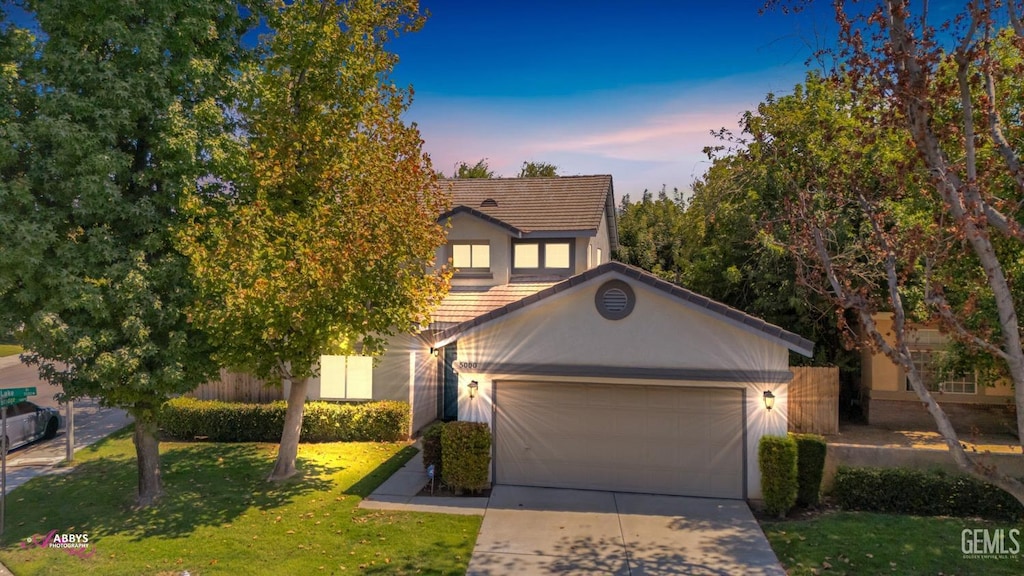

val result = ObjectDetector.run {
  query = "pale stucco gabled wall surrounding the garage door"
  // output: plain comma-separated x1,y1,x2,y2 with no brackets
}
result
444,275,788,498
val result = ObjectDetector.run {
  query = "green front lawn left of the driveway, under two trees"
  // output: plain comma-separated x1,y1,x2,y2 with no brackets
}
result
0,430,480,576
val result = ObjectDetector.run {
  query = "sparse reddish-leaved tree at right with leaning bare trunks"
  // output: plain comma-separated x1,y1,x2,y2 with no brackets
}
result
760,0,1024,502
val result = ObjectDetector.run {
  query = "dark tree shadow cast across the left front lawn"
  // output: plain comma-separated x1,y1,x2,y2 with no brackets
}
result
4,444,343,542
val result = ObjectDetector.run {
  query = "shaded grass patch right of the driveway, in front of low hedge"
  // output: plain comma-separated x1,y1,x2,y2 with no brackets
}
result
761,512,1024,576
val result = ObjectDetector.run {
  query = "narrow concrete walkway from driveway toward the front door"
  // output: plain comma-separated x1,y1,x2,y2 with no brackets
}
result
360,451,488,512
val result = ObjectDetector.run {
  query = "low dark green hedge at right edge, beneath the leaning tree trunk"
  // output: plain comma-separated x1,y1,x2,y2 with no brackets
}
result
831,466,1024,521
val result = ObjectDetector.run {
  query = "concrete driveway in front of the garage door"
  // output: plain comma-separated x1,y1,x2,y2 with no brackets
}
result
467,486,785,576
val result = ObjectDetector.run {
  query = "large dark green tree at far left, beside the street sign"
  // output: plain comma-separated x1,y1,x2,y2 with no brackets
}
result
0,0,247,505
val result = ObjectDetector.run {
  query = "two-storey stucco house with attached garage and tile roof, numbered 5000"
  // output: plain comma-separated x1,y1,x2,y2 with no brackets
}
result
299,175,813,498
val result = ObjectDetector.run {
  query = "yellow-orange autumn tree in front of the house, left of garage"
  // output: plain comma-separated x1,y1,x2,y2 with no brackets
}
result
182,0,447,480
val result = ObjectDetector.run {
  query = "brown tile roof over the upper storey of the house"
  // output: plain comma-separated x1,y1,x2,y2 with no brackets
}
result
441,174,617,236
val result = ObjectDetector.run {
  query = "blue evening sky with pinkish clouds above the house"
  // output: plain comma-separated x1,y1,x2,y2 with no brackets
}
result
392,0,835,198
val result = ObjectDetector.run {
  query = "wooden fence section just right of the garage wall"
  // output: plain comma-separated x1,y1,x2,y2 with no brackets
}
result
787,366,839,434
